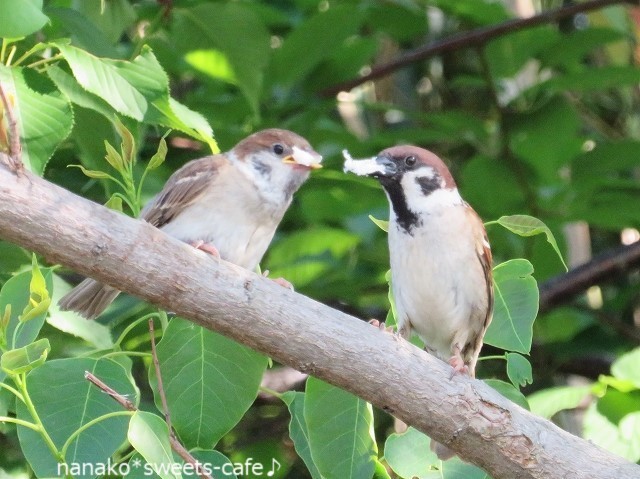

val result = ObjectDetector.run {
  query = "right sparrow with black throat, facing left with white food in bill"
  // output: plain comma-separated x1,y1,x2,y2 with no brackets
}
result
343,145,493,459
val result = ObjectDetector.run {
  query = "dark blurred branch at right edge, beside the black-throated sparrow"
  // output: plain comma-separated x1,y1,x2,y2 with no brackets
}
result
540,241,640,313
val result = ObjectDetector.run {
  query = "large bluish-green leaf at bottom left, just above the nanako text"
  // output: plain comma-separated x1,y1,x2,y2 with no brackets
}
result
16,358,137,478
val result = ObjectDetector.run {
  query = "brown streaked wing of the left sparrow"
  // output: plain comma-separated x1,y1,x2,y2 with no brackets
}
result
140,155,227,228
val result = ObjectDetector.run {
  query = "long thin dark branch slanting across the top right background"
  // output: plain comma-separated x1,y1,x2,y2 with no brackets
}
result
320,0,640,97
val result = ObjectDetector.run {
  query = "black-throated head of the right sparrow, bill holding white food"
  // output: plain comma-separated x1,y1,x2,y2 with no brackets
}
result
342,145,463,231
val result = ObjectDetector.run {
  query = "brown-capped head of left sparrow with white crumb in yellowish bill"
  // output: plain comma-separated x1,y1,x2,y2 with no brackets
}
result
229,128,322,205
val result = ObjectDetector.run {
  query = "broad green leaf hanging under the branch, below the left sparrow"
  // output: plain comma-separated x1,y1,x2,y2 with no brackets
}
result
151,318,267,448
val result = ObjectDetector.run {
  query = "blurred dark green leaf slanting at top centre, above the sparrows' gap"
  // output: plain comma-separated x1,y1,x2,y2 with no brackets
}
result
270,4,363,87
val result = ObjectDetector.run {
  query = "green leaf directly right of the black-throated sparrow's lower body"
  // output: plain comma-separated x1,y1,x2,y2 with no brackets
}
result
484,259,539,354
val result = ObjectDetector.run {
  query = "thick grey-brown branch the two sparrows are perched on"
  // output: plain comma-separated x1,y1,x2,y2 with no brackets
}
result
0,162,640,479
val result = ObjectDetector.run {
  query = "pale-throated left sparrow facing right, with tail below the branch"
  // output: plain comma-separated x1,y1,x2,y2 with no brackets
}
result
59,128,322,319
